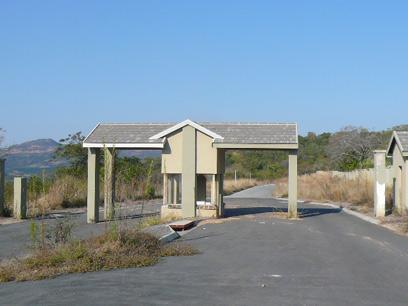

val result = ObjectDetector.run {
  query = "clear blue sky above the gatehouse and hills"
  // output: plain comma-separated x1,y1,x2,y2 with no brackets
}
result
0,0,408,144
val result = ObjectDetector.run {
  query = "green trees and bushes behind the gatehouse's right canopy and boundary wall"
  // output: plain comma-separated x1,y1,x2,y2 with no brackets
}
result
225,125,408,181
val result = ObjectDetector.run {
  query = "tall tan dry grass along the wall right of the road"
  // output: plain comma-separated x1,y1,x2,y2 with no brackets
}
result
274,172,391,207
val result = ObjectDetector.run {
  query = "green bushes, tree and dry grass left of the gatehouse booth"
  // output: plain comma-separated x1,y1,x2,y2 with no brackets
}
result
5,133,162,216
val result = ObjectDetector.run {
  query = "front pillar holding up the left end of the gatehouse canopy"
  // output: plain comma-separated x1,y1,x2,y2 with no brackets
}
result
86,148,100,223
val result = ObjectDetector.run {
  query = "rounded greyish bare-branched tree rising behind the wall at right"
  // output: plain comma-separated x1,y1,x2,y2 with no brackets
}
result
327,126,383,168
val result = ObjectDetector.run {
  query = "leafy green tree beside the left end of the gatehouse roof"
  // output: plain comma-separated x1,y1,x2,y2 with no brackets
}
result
54,132,88,175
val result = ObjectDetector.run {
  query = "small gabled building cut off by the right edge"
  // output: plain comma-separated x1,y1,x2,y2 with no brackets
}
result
384,131,408,214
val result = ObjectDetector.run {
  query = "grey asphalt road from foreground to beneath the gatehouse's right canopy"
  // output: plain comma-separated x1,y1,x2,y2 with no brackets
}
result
0,185,408,305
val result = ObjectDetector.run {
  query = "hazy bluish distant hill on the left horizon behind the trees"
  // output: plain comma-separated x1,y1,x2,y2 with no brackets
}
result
1,139,160,178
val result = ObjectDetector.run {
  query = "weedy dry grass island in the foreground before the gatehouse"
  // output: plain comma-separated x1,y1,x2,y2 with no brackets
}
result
0,229,197,282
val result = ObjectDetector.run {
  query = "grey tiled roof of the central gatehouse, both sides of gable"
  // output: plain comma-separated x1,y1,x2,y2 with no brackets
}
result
84,123,297,144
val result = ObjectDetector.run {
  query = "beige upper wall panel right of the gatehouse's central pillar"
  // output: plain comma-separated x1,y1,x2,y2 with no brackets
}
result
197,131,217,174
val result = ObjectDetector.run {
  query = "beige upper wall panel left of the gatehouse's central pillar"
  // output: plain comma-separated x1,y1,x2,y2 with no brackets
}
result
162,130,183,173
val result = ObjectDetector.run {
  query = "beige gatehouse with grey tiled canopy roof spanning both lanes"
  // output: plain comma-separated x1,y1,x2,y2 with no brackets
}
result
83,120,298,223
